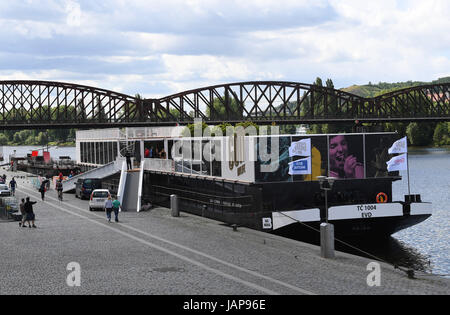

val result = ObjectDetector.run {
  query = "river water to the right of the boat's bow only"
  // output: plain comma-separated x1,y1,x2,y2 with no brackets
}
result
393,149,450,275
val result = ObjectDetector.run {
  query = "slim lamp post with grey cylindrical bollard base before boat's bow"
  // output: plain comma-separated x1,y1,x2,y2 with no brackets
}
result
317,176,336,258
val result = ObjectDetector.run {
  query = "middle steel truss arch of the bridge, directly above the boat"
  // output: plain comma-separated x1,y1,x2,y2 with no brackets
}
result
157,81,365,123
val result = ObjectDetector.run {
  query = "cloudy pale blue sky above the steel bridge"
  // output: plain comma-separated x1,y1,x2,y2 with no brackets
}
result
0,0,450,98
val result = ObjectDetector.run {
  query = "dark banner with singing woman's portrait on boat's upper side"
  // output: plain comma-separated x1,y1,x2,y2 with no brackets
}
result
255,133,395,182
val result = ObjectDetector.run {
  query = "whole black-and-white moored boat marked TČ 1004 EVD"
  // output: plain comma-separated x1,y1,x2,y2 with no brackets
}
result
76,126,431,238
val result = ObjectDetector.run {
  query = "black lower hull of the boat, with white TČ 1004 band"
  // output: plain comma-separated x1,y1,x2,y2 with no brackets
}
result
143,171,431,239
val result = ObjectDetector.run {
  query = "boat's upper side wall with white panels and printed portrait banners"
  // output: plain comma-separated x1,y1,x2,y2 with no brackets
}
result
168,133,395,183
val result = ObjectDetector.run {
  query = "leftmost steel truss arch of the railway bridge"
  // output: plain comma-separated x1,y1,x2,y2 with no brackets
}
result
0,80,142,129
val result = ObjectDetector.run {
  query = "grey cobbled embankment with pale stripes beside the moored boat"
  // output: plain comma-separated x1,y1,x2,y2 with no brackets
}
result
0,170,450,295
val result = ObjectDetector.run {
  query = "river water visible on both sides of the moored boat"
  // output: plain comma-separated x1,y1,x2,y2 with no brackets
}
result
3,146,450,277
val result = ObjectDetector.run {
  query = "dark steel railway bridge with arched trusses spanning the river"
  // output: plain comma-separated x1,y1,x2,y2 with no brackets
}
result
0,81,450,129
